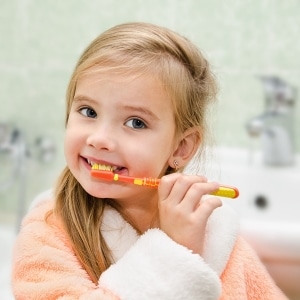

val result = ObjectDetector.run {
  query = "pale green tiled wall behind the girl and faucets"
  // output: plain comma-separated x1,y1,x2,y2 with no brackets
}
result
0,0,300,216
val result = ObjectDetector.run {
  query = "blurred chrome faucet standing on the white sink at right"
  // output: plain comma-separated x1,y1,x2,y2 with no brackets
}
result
246,76,297,166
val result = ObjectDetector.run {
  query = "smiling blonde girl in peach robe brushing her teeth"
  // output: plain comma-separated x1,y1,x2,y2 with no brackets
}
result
12,23,286,300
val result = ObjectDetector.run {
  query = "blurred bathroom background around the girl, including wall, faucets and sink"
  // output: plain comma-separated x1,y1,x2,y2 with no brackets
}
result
0,0,300,300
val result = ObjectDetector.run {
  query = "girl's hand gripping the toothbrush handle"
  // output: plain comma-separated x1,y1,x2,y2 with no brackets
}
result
158,173,222,255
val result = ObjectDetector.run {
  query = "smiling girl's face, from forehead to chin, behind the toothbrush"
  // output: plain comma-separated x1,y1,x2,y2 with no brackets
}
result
65,72,176,199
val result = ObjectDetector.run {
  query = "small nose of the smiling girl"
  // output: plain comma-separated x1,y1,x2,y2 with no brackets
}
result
86,124,117,151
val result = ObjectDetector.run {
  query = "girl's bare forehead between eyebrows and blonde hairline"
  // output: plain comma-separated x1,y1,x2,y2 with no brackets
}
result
75,67,173,114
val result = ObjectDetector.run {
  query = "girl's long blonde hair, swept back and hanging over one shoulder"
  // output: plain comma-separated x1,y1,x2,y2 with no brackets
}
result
54,23,217,283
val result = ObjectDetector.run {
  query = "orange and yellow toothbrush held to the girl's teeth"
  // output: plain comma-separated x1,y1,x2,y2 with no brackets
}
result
91,166,239,198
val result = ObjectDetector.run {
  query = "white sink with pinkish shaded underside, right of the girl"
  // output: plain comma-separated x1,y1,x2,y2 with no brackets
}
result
187,148,300,299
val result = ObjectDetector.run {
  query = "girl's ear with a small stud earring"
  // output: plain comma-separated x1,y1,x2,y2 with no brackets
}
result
169,127,201,169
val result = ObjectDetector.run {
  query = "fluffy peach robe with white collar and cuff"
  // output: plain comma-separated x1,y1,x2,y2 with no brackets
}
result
12,193,287,300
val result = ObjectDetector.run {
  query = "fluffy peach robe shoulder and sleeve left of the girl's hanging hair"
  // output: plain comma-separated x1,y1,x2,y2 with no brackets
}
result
11,192,115,299
